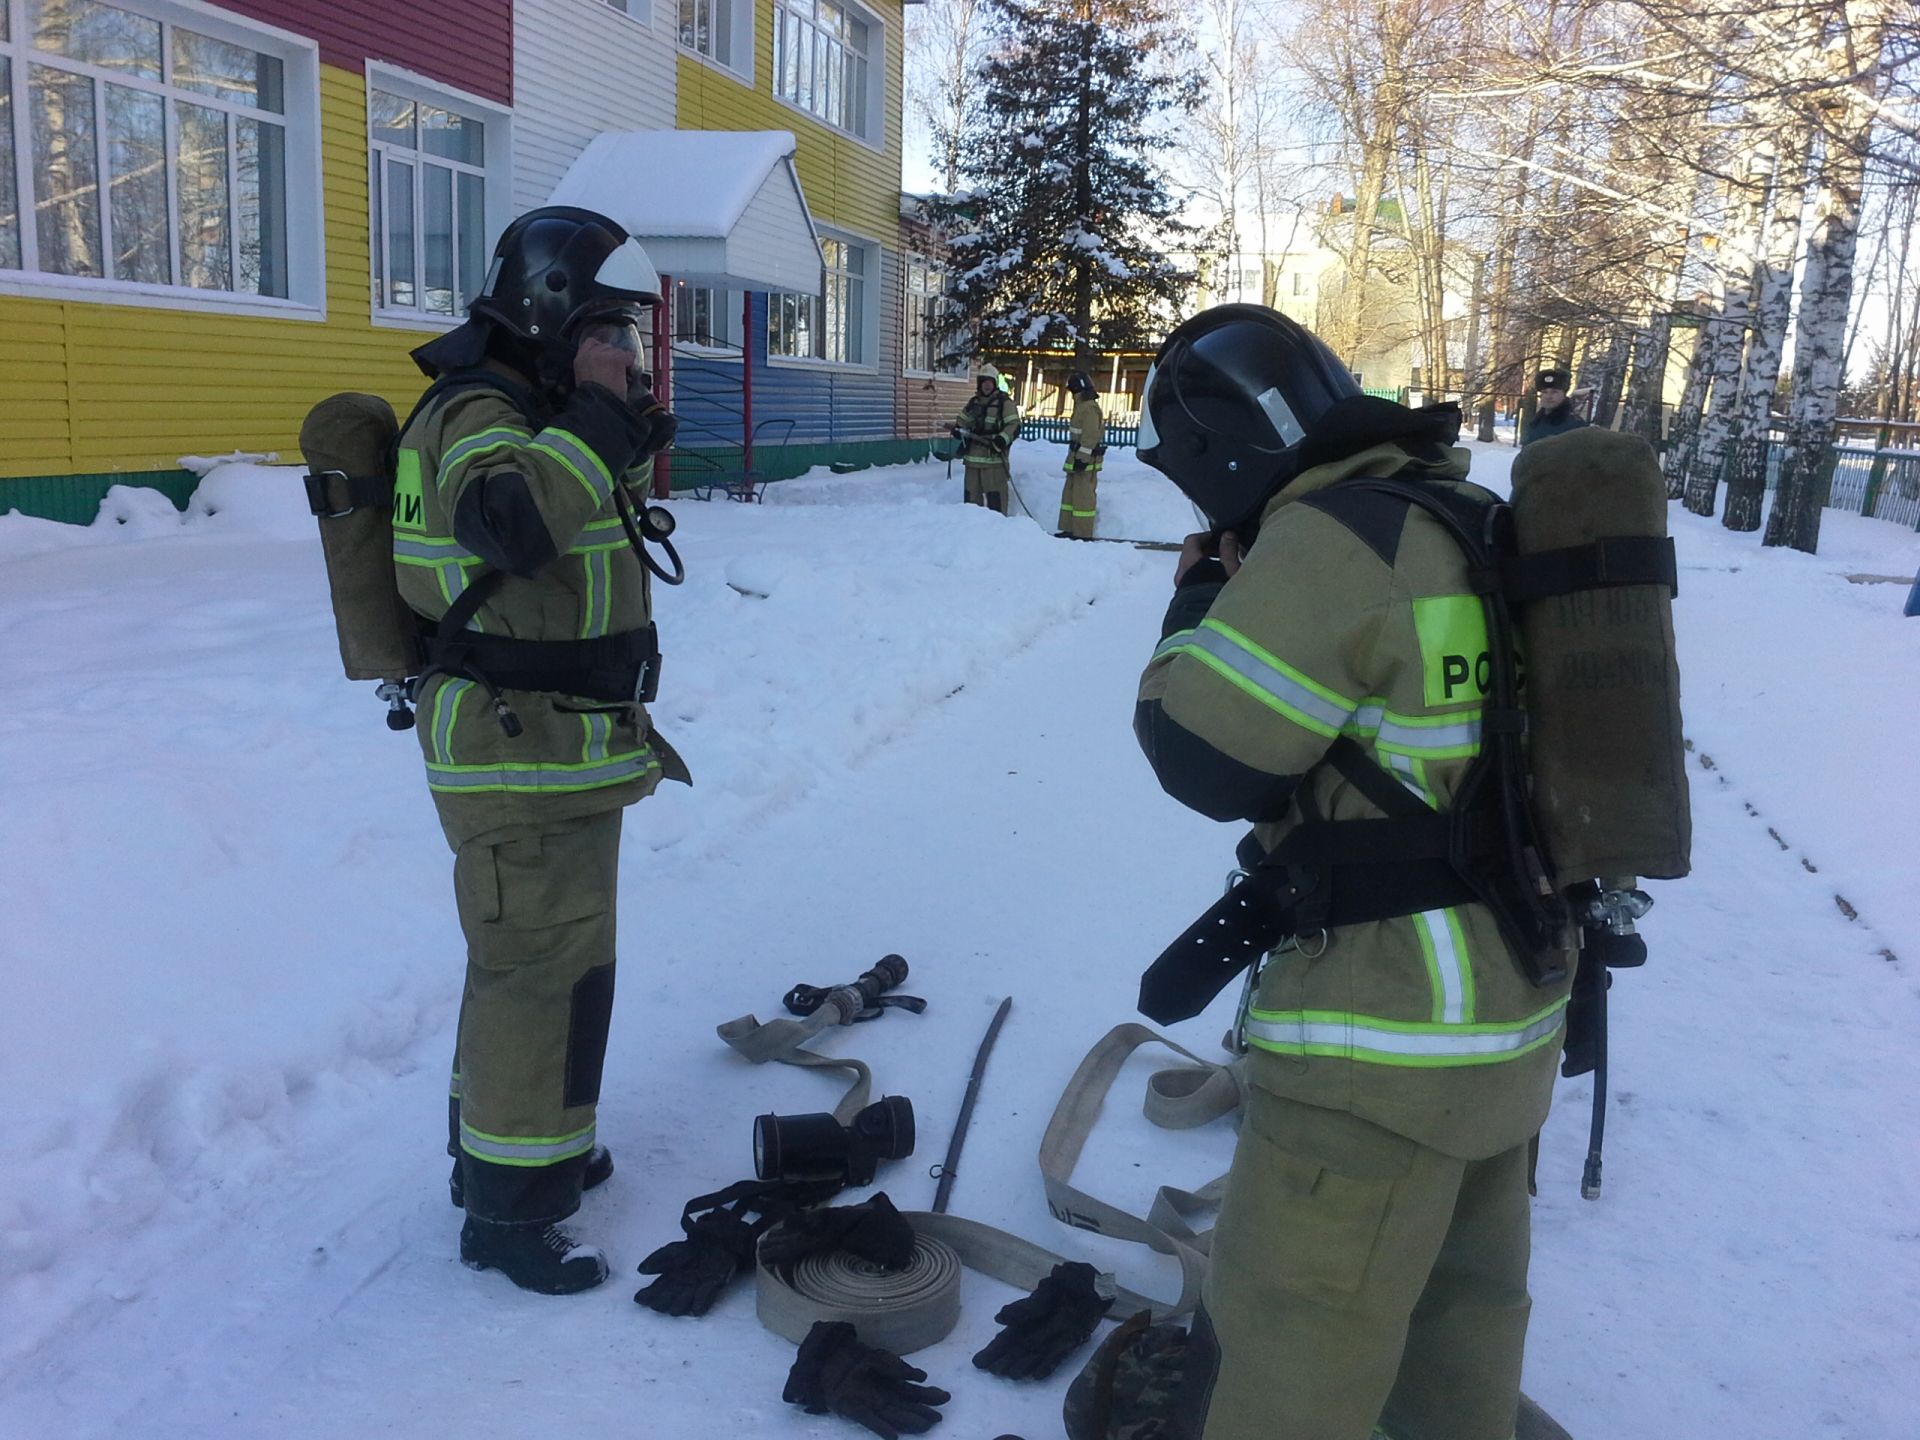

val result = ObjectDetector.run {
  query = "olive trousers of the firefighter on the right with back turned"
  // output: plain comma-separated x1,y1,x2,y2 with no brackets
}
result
1187,1087,1530,1440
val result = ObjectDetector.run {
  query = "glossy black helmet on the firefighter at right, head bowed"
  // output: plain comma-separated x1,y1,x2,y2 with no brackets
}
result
1139,305,1361,530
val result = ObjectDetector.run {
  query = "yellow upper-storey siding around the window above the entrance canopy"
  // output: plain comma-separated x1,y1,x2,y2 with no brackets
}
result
674,0,904,246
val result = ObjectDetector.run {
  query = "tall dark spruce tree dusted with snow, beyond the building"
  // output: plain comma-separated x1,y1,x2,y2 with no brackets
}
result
941,0,1200,361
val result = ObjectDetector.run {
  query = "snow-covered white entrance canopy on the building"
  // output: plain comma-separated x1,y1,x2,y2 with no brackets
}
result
551,131,820,290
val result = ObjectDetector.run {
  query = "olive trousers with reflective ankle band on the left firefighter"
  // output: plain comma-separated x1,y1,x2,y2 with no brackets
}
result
447,810,622,1225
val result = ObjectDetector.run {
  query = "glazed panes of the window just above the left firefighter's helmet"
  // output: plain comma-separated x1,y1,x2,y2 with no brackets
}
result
369,86,490,317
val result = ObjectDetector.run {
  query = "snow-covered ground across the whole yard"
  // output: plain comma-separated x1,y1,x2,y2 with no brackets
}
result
0,444,1920,1440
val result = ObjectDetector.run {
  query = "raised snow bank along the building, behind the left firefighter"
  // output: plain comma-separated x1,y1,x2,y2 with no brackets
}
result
0,445,1140,1359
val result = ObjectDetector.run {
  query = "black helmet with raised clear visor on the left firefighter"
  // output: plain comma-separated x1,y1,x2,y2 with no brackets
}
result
472,205,660,351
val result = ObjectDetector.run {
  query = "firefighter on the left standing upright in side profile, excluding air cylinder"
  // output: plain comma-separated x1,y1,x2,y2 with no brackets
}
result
394,207,687,1294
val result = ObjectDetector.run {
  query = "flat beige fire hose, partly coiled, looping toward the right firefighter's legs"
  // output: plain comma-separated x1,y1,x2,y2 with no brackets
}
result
755,1021,1240,1356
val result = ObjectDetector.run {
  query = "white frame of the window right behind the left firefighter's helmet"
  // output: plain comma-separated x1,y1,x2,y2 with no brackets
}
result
365,61,513,330
